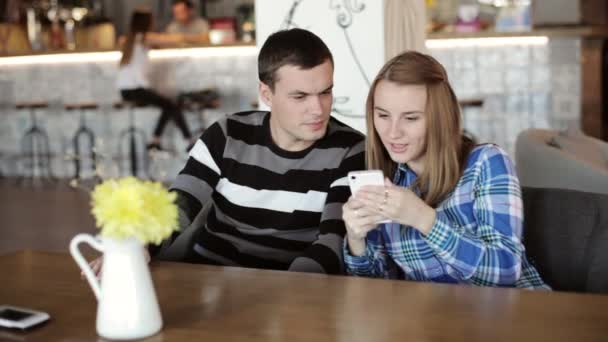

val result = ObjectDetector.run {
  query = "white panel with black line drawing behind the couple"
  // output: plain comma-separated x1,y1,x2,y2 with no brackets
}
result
255,0,384,131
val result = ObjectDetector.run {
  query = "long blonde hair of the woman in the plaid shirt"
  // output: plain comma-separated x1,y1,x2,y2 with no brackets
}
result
365,51,475,207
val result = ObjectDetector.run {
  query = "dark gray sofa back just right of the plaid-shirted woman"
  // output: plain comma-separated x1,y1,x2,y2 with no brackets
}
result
523,187,608,293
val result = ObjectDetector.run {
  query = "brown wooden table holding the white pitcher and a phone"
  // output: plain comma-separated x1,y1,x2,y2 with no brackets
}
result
0,251,608,342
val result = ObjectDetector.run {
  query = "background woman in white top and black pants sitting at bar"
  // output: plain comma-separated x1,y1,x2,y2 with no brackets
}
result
117,10,195,150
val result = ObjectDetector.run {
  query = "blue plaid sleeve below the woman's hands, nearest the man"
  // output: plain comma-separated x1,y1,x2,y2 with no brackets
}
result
343,229,397,279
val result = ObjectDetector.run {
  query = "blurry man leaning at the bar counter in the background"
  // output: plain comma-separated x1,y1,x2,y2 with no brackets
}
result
165,0,209,43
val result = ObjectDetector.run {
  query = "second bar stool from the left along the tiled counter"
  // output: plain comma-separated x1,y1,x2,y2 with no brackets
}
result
64,102,99,179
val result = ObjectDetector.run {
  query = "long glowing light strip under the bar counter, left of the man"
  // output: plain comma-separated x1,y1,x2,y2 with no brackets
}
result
0,46,258,66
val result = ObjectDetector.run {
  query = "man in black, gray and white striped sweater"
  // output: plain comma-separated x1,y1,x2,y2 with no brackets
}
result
159,29,365,273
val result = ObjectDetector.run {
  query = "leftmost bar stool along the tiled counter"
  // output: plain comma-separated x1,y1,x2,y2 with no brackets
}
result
15,102,54,180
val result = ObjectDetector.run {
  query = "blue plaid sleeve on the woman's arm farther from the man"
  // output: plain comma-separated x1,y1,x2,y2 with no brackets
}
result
425,146,524,286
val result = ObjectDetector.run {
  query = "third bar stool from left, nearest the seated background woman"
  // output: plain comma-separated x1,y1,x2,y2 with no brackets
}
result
114,101,148,176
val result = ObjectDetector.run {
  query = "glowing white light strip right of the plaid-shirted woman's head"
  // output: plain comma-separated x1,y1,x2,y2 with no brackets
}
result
426,36,549,49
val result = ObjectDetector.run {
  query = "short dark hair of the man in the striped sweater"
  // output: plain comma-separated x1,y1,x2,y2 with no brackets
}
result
258,28,334,91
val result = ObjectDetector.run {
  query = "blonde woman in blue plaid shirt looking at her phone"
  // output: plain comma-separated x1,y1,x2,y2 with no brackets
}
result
343,52,549,289
